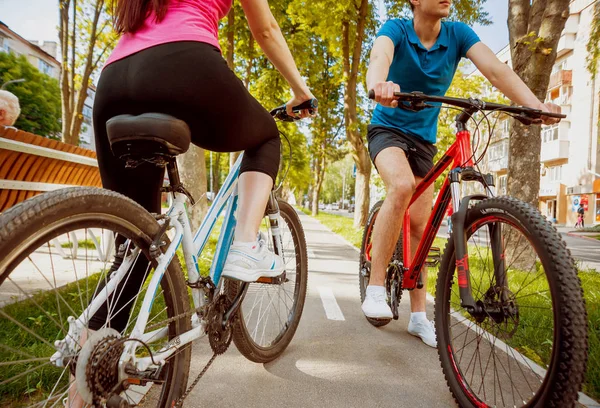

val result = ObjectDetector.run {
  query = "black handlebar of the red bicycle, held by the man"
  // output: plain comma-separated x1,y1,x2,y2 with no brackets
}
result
369,89,567,125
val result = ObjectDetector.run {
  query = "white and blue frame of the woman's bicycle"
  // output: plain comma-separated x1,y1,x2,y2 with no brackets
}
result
52,153,283,371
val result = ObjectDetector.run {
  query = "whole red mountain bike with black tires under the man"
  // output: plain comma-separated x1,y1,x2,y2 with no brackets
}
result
359,92,587,407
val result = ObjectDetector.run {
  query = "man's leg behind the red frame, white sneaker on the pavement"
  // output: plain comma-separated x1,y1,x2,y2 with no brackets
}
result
408,177,437,347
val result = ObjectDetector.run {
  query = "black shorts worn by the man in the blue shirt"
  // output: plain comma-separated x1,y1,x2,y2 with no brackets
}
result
367,125,437,178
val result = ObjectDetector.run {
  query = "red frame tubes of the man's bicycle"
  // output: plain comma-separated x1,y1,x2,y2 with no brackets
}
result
402,130,473,289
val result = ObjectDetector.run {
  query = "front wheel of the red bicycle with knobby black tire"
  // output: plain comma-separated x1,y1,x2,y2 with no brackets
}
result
435,197,587,407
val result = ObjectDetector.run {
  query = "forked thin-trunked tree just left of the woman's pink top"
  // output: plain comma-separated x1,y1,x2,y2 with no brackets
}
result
58,0,117,145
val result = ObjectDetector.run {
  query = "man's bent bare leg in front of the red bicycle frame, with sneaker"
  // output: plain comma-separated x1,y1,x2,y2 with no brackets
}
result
362,147,415,318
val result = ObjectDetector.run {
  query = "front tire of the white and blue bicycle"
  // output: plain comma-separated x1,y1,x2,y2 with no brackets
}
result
225,200,308,363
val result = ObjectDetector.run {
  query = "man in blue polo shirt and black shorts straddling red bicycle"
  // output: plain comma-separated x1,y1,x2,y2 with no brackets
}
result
362,0,560,347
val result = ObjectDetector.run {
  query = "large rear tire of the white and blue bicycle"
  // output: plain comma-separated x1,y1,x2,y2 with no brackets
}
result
0,187,191,407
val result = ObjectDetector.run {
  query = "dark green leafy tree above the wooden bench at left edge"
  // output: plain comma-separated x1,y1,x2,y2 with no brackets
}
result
0,53,60,135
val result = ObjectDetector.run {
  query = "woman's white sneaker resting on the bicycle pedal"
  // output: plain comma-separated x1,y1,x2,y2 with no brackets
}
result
223,233,284,282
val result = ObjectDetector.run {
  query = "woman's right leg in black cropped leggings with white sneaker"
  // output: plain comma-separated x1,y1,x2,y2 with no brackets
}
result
123,42,283,281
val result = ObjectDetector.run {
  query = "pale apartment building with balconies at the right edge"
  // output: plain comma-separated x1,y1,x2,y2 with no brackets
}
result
473,0,600,226
